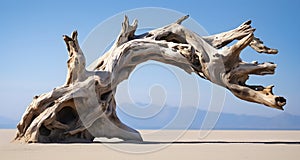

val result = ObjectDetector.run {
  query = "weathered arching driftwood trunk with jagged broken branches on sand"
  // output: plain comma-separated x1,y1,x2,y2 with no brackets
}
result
15,16,286,143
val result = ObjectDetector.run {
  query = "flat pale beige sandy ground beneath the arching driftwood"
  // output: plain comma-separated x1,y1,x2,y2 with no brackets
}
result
0,130,300,160
